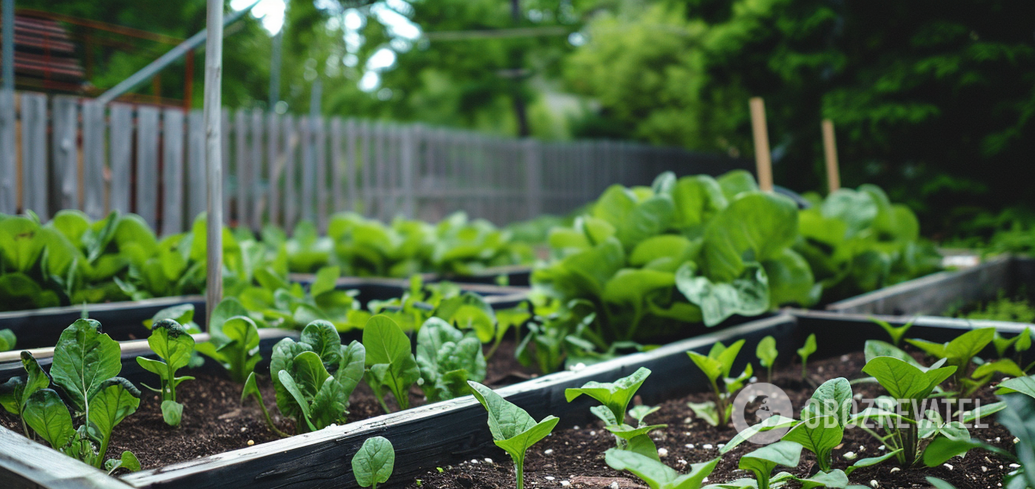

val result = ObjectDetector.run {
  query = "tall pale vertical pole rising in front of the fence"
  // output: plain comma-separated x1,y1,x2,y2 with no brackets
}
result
205,0,223,330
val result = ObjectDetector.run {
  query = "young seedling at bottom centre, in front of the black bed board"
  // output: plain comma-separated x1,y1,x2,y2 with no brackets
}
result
467,380,560,489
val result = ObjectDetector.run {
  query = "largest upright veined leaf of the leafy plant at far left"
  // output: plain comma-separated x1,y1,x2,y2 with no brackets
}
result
51,319,122,412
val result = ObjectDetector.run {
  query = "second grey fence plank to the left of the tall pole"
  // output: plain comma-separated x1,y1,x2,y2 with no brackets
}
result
161,108,184,236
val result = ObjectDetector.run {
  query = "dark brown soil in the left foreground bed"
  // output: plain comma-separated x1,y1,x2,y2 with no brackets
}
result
0,341,535,469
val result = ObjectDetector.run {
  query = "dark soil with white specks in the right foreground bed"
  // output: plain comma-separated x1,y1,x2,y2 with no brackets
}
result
403,353,1013,489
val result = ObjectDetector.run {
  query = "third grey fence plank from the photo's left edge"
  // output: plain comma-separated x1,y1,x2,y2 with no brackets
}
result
50,95,79,209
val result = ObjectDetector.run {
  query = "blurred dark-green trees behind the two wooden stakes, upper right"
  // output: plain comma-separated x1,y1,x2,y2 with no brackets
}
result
565,0,1035,234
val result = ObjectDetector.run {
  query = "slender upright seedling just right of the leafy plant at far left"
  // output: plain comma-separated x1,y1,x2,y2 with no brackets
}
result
137,319,195,426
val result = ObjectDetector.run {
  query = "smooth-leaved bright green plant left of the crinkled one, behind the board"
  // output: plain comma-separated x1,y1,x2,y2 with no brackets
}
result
363,315,420,412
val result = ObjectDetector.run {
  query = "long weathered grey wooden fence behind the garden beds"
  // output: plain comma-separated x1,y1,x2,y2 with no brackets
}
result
0,92,748,234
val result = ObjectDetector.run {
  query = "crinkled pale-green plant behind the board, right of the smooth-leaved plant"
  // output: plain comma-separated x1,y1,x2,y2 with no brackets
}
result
416,317,485,402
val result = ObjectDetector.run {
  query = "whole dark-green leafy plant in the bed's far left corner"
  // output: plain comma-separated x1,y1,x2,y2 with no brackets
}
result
10,319,140,469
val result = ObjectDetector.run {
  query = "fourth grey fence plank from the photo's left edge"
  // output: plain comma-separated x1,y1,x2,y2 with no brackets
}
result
83,100,108,219
